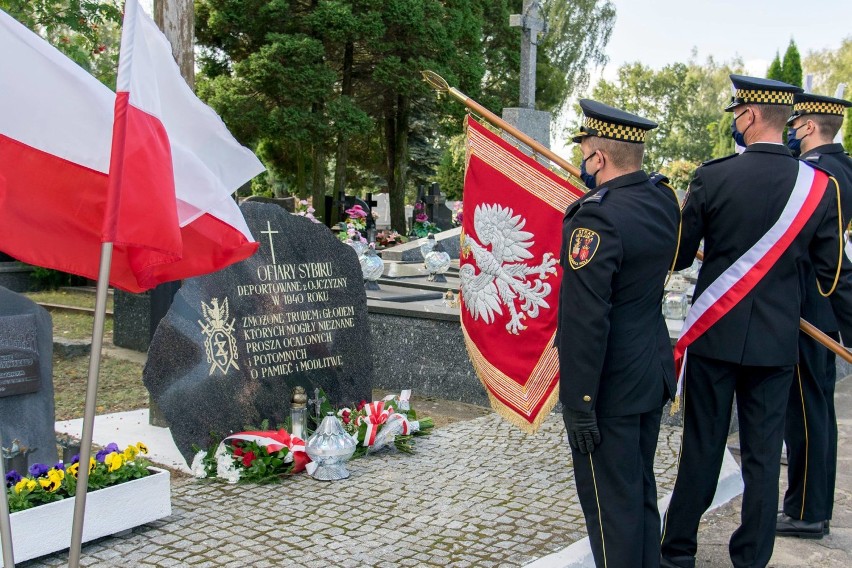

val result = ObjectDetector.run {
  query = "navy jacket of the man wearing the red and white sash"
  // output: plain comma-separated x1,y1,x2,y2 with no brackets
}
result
676,143,852,366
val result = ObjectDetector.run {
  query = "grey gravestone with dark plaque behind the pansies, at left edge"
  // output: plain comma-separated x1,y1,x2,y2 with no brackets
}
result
0,287,56,473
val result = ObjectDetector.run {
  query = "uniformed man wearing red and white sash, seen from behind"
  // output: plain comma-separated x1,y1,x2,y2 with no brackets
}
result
661,75,852,568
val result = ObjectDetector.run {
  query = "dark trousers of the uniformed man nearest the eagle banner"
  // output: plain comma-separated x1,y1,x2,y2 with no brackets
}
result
571,406,662,568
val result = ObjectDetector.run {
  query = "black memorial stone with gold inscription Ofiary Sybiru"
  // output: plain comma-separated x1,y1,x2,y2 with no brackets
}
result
143,202,373,462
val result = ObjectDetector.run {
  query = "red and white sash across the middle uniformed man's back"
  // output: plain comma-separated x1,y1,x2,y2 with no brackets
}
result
674,162,828,395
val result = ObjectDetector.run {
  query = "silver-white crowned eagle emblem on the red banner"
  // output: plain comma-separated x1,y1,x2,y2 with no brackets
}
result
459,204,558,335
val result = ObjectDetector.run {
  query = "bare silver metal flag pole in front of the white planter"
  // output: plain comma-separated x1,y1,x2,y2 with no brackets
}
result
68,243,112,568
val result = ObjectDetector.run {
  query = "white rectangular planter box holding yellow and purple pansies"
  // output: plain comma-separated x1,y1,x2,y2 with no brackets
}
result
0,467,172,563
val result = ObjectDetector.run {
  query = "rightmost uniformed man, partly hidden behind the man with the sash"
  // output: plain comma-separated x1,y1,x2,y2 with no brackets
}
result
775,94,852,538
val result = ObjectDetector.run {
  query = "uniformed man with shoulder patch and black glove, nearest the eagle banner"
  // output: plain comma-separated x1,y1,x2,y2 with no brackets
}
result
557,99,680,568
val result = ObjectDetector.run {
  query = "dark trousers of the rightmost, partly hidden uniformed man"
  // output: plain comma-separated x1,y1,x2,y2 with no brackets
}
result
784,332,839,522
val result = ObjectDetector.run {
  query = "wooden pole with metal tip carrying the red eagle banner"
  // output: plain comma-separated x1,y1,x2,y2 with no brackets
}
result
421,70,852,363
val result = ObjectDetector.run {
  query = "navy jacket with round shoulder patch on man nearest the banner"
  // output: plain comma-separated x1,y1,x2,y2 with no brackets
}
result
557,170,680,416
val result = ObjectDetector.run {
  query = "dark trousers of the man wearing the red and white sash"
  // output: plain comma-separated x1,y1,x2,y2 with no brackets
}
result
661,354,794,568
